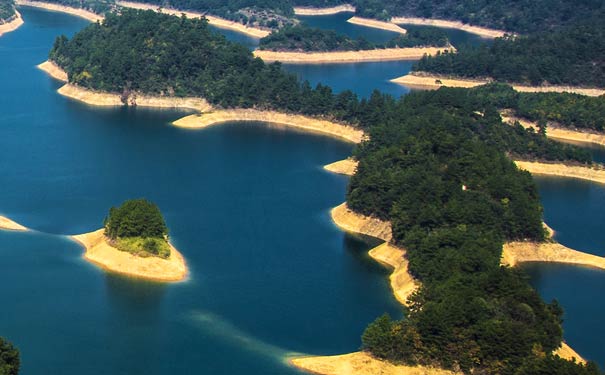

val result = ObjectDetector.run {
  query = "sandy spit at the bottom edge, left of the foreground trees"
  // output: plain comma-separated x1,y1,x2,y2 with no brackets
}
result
289,352,460,375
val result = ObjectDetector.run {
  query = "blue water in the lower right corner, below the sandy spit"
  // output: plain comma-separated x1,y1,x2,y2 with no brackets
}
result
523,263,605,369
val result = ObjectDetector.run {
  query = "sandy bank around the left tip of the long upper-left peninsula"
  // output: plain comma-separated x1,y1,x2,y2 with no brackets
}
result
38,61,212,111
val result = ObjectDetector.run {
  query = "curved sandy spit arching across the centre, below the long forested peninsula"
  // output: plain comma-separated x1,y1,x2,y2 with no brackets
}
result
173,109,364,143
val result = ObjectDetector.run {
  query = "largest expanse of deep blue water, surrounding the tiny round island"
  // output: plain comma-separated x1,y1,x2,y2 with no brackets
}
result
0,8,402,375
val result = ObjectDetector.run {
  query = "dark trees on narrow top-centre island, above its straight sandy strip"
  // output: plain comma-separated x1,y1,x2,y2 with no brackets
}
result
259,25,449,52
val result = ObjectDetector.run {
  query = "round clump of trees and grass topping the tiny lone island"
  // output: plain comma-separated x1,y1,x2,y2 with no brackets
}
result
104,199,170,258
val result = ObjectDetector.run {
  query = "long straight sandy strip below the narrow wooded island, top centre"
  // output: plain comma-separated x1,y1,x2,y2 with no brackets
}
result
254,47,453,64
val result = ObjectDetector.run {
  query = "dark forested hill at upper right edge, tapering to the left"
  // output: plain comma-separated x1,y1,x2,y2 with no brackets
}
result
413,19,605,87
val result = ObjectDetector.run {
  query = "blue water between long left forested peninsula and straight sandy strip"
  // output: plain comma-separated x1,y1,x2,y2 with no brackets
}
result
284,61,413,98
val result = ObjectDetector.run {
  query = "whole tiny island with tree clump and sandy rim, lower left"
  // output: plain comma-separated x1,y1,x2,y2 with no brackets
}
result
72,199,187,281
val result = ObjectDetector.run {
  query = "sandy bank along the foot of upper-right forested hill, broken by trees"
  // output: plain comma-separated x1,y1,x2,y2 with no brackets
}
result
391,72,605,96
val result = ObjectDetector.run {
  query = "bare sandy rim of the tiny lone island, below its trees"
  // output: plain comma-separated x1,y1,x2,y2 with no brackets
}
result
70,229,188,281
